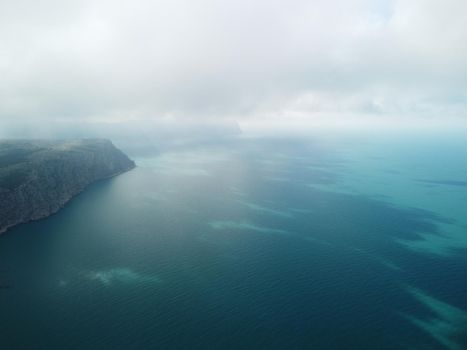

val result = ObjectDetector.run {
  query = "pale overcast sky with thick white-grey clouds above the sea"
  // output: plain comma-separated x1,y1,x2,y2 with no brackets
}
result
0,0,467,126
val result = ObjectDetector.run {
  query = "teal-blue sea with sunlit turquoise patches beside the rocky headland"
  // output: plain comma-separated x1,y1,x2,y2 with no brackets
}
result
0,133,467,350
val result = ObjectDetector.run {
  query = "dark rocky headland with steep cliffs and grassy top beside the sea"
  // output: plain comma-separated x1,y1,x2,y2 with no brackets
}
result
0,139,135,233
